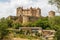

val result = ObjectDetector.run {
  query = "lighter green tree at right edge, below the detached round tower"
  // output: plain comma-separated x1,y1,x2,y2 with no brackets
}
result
49,16,60,31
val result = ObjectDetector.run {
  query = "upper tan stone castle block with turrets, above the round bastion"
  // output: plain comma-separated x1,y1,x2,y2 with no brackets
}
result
17,7,41,17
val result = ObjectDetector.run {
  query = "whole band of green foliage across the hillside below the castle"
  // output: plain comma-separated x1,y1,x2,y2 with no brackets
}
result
0,16,60,40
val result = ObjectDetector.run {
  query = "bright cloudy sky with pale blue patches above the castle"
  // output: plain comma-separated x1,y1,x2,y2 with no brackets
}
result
0,0,59,18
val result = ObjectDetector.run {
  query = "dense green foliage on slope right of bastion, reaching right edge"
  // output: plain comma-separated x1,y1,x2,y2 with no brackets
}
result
26,16,60,31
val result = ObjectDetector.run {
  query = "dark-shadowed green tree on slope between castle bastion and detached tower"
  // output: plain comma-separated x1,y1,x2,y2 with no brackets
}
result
35,17,50,29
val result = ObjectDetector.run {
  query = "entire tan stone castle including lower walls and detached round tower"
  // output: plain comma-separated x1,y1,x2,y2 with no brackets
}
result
9,7,55,24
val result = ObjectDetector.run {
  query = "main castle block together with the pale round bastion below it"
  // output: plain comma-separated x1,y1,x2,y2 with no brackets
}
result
16,7,41,23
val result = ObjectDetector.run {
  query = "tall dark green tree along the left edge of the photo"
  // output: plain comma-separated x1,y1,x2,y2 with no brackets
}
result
0,18,8,40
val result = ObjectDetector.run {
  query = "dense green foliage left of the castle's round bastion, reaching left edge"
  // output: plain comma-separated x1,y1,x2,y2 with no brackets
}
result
0,18,21,40
